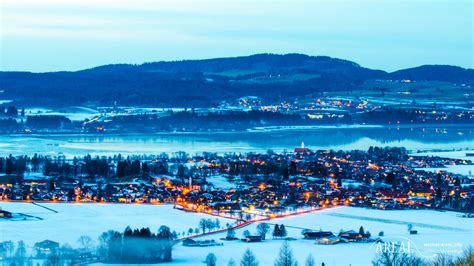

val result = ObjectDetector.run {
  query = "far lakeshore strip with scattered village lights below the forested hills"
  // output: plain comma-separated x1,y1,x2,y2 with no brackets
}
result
0,92,474,134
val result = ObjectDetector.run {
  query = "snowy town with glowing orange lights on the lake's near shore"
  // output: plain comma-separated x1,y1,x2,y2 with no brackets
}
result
0,144,474,216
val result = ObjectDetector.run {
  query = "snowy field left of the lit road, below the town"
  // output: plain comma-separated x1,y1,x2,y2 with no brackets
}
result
0,202,235,246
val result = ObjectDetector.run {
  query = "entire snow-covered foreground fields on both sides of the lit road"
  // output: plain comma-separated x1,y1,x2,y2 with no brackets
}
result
0,202,474,265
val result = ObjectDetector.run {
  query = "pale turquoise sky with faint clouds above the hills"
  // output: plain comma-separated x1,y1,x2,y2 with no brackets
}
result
0,0,474,72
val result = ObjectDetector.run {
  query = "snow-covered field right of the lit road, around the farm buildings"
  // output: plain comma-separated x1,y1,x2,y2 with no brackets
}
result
168,207,474,265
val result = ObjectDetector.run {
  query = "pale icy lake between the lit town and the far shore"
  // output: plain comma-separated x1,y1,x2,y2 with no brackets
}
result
0,126,474,156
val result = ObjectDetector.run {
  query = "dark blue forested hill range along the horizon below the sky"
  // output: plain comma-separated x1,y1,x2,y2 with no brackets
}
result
0,54,474,107
